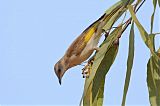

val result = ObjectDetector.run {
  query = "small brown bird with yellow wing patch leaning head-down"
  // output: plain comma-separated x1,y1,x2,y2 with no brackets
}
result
54,14,105,85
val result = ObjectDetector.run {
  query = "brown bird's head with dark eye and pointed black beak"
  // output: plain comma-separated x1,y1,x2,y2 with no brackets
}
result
54,60,67,85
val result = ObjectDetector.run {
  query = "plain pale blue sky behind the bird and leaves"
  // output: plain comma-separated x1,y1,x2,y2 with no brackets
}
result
0,0,160,106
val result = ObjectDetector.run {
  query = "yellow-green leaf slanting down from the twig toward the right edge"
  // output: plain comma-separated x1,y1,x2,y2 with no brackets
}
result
128,5,160,61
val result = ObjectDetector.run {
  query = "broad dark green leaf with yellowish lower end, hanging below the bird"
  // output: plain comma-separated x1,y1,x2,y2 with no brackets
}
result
83,45,118,106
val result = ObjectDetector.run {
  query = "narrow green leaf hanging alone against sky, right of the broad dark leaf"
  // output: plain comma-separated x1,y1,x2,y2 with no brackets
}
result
122,23,134,106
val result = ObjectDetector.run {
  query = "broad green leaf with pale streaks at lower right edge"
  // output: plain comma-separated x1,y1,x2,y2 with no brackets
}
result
147,56,160,106
